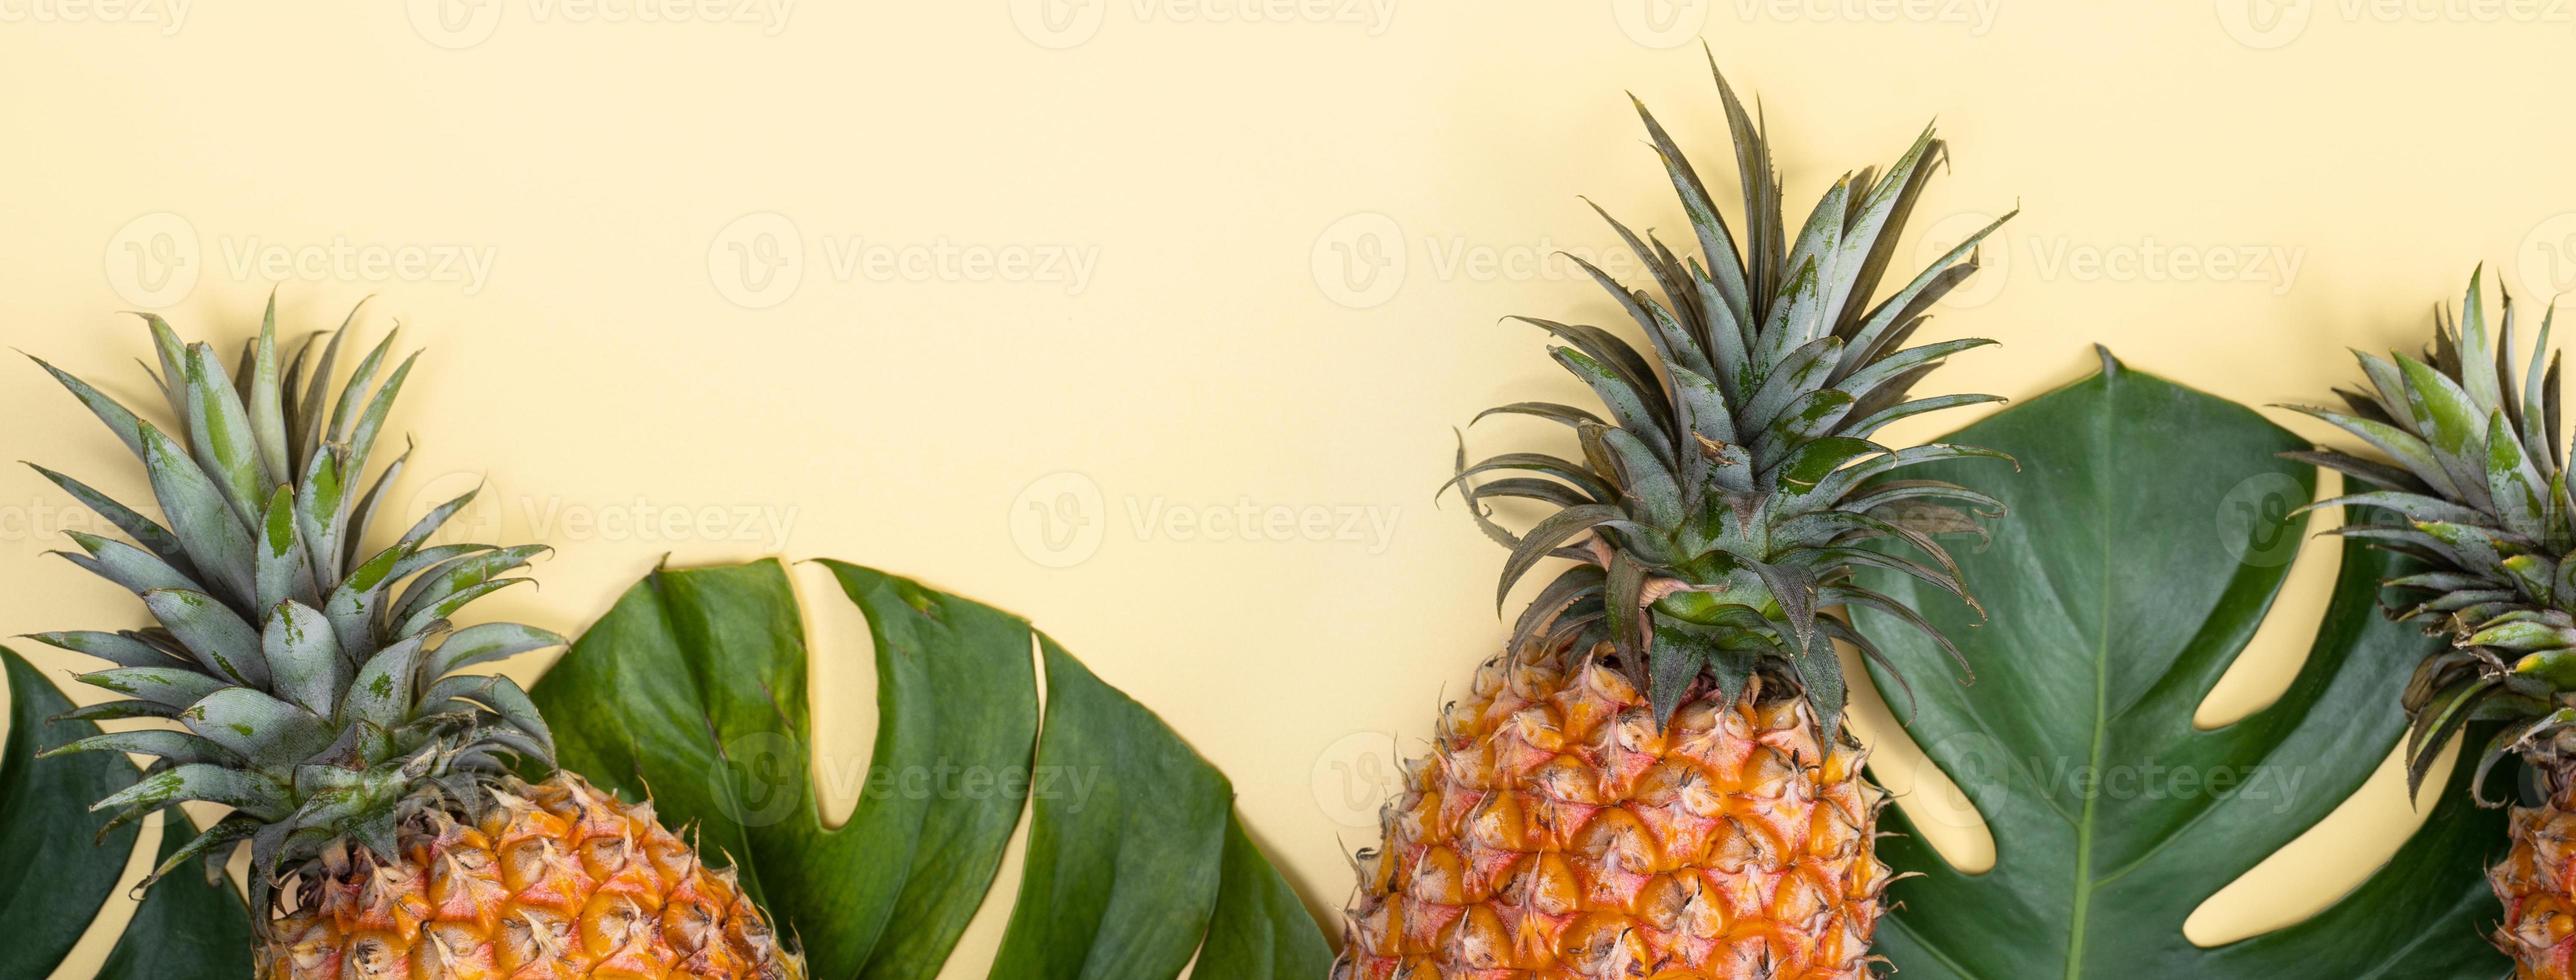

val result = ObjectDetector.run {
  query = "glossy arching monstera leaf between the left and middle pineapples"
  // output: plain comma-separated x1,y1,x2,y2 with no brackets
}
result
531,560,1332,980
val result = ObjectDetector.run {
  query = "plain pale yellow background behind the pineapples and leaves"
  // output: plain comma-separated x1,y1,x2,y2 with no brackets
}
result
0,0,2576,977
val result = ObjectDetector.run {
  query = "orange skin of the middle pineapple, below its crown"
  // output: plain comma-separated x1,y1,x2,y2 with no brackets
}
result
1332,658,1888,980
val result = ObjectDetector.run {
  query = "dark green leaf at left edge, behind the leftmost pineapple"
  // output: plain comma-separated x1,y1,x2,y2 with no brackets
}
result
0,647,250,980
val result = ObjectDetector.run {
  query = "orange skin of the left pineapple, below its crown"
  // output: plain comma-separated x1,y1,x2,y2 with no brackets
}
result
258,771,804,980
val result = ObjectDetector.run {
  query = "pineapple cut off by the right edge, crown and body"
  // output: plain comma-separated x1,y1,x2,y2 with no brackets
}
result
2293,273,2576,977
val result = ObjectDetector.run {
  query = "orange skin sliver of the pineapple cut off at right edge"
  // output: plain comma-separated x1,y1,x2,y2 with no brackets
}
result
2486,766,2576,980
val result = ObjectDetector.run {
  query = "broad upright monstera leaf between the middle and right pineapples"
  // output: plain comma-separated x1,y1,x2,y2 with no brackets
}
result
1860,353,2509,980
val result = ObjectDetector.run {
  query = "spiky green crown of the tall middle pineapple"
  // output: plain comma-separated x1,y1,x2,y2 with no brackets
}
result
1443,59,2012,743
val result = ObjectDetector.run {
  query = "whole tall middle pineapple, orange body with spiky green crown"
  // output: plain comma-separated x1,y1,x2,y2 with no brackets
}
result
1334,64,2009,980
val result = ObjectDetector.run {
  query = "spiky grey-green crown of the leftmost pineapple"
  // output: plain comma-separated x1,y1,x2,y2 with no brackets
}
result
36,297,564,905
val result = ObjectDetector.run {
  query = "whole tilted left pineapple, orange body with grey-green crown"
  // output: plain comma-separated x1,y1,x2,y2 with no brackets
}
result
36,299,804,980
